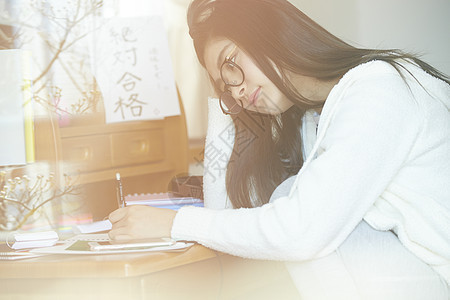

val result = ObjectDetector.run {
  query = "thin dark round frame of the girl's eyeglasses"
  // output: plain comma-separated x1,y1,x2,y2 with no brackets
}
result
219,46,245,115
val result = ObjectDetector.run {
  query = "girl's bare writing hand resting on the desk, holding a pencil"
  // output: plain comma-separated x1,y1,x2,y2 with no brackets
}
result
108,205,177,240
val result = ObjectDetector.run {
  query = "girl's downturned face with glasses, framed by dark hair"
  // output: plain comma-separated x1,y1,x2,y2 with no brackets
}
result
204,39,293,115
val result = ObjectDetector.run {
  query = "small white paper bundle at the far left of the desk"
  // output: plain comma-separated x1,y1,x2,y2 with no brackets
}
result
7,231,59,250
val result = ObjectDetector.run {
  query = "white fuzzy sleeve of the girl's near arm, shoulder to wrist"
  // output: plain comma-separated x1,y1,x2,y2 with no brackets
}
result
172,68,422,260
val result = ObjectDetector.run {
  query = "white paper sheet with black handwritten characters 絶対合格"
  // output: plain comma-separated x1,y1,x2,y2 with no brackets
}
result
92,15,180,123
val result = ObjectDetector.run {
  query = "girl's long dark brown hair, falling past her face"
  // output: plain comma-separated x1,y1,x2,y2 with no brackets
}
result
188,0,450,208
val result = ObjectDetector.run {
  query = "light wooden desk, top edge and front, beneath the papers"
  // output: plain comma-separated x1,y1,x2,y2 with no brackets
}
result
0,245,299,300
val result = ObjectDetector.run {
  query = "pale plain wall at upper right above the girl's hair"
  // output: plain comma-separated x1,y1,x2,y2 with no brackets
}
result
291,0,450,74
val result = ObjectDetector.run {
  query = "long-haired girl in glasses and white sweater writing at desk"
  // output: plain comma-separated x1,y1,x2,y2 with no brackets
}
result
110,0,450,299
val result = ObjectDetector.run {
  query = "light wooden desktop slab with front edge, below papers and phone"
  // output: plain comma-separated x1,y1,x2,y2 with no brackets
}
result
0,245,217,279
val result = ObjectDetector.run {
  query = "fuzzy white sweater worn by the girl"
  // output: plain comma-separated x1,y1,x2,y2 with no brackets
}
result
172,61,450,283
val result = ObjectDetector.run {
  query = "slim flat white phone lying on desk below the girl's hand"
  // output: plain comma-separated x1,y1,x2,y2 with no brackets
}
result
89,237,176,251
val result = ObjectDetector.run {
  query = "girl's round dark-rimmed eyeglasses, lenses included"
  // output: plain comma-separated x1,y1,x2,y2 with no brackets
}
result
219,46,245,115
